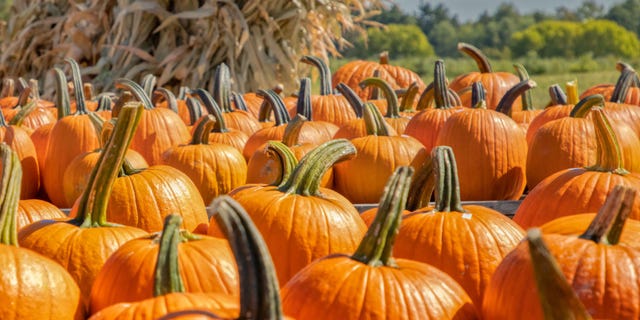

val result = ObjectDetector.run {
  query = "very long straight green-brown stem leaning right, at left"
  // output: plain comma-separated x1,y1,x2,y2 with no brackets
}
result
69,103,143,228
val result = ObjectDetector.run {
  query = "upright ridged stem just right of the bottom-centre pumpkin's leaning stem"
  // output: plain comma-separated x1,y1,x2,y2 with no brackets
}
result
431,146,466,212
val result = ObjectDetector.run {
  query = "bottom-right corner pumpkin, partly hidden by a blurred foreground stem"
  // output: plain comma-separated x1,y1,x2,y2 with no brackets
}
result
482,186,640,319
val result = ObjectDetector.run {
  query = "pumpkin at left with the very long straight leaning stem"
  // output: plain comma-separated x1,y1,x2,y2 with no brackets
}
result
18,104,146,307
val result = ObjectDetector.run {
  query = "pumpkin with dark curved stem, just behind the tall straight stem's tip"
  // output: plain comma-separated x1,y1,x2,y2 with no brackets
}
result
116,79,190,166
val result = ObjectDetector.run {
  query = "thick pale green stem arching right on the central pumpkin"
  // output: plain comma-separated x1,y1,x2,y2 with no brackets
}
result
278,139,356,196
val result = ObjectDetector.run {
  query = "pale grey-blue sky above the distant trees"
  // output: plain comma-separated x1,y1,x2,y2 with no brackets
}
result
394,0,624,21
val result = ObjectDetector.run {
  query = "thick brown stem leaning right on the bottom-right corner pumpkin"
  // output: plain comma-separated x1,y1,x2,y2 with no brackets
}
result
580,185,636,245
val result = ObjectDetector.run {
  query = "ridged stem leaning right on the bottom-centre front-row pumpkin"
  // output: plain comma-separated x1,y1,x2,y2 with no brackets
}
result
351,166,413,267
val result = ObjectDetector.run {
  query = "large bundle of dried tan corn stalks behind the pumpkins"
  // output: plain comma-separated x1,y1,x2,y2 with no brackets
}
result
0,0,383,96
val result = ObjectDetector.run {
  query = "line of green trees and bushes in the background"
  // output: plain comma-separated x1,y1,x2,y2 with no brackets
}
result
343,0,640,59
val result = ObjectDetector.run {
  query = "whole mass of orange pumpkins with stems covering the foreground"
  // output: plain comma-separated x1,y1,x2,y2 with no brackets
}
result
0,43,640,319
